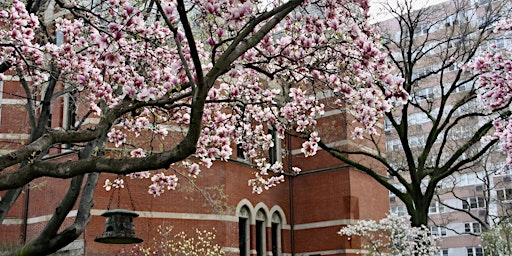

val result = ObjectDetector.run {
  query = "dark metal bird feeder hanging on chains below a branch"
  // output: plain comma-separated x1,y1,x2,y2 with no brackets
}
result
94,209,143,244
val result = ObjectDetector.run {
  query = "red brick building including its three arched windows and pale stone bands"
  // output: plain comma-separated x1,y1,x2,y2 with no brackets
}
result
0,73,389,256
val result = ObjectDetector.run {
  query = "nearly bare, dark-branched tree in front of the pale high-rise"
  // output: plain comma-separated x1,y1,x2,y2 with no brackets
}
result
318,0,512,227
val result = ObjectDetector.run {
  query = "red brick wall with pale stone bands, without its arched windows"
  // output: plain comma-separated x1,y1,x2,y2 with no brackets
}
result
0,76,388,255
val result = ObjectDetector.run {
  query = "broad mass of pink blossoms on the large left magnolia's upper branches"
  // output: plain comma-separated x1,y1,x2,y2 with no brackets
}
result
0,0,408,195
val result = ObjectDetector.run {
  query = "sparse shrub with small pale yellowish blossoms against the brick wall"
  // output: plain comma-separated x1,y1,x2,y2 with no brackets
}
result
123,225,226,256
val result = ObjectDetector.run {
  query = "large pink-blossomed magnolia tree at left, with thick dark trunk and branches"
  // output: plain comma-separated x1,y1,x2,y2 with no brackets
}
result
0,0,407,255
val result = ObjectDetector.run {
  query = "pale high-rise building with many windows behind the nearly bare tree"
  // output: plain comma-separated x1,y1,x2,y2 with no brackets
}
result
380,0,512,256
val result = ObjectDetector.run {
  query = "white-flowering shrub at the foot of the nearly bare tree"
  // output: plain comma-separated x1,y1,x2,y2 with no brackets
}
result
338,214,439,256
